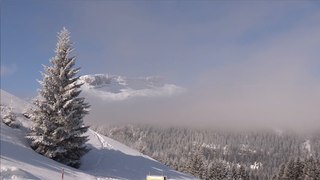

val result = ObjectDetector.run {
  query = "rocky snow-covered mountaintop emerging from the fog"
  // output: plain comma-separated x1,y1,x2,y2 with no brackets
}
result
79,74,185,101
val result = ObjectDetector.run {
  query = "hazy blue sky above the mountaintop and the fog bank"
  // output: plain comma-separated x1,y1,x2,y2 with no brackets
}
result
1,0,320,93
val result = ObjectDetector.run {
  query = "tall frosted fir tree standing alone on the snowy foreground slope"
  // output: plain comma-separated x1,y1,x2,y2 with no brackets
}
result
28,28,89,168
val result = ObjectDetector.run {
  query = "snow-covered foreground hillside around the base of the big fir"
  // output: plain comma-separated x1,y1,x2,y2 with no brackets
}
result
1,90,194,180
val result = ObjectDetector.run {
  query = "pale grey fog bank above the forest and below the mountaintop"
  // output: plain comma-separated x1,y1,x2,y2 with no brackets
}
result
83,9,320,131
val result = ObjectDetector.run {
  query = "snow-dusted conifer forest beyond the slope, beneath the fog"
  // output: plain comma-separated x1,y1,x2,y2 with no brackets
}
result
91,125,320,179
